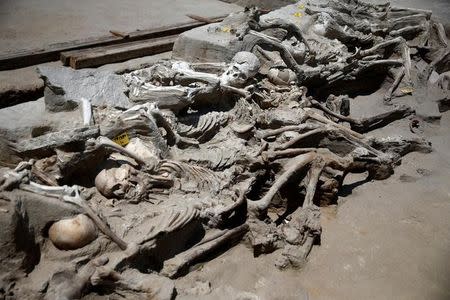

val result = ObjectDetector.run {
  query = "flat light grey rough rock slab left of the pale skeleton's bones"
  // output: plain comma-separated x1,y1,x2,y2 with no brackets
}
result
38,66,131,112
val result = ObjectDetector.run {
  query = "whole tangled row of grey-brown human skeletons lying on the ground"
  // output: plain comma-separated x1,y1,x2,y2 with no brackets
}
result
0,0,449,299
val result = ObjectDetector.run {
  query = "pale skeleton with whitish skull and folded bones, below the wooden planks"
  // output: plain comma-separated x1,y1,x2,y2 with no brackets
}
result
124,52,259,112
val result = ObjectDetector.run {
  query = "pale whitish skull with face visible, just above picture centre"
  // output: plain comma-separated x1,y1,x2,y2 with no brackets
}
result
220,51,260,87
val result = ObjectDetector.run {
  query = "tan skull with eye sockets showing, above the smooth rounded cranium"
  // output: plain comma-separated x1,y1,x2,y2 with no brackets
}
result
95,164,136,199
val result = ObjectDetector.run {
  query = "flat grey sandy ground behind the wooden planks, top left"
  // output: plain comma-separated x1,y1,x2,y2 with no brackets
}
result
0,0,240,55
